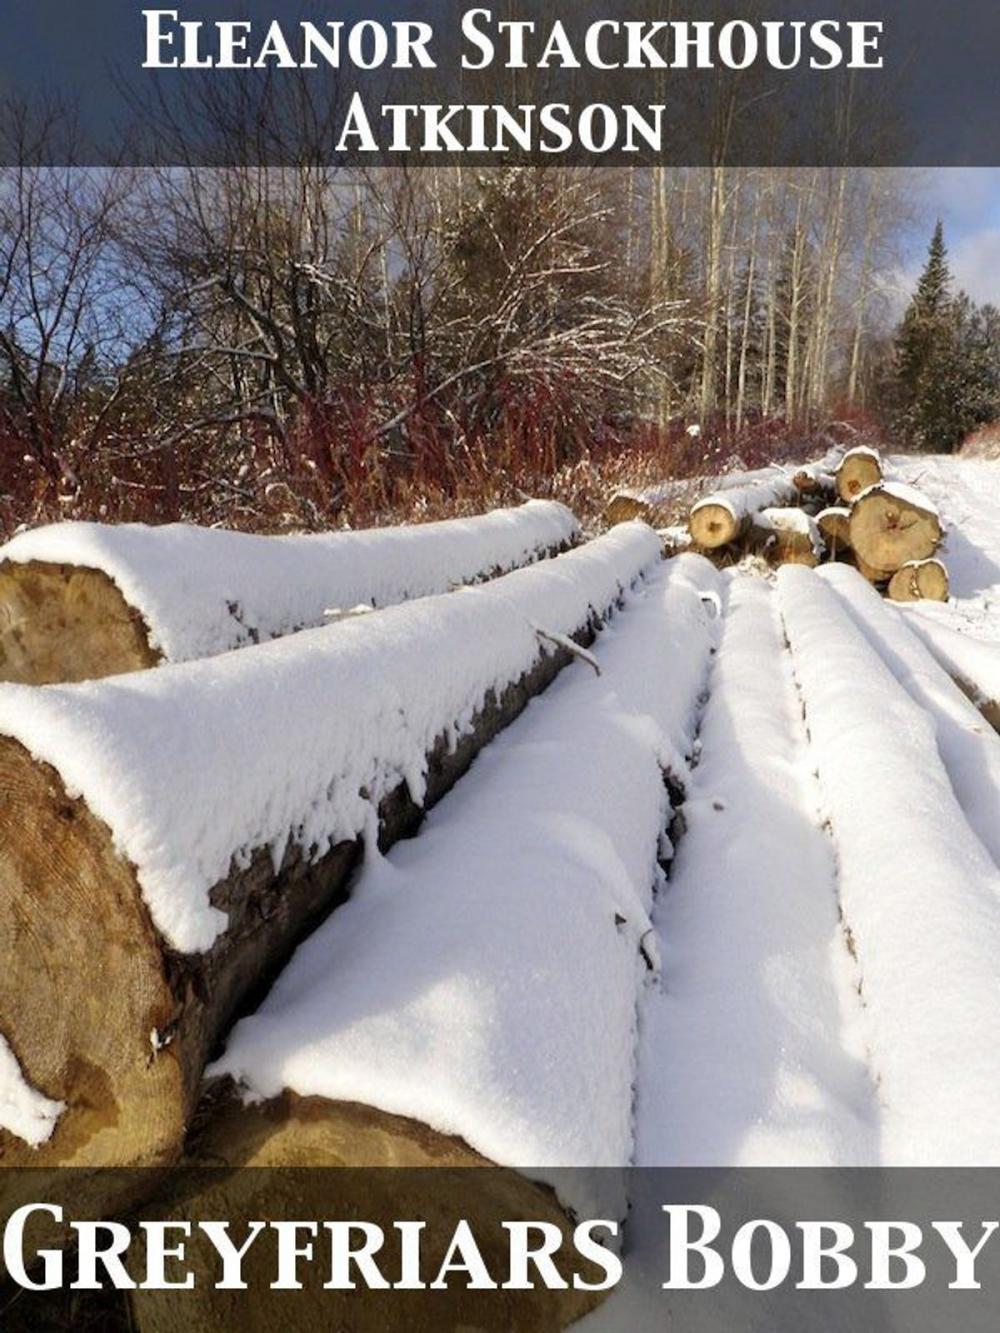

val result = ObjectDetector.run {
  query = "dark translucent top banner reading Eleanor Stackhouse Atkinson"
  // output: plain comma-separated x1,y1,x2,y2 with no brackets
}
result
0,0,1000,167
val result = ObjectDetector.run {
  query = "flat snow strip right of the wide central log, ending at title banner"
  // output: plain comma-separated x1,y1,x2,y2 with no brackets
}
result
635,572,873,1167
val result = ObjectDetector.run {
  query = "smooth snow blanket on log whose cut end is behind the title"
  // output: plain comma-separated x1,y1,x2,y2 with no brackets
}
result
197,556,719,1216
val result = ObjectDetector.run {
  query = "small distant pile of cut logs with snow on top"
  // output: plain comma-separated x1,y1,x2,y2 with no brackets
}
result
688,445,949,601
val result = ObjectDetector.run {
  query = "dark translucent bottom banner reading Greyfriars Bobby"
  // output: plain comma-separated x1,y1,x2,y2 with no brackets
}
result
0,1168,1000,1333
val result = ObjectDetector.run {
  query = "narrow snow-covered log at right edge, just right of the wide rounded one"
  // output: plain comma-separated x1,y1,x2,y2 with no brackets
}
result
820,565,1000,865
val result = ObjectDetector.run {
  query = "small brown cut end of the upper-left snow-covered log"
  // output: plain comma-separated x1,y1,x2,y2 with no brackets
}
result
0,561,160,685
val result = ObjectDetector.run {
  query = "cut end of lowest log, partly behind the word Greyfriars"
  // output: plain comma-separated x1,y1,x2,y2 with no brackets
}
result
132,1084,603,1333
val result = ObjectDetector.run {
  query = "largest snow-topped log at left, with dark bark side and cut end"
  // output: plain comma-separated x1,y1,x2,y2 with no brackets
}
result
0,524,660,1165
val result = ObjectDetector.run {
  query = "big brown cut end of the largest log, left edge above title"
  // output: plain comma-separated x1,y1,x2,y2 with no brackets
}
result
0,738,183,1166
